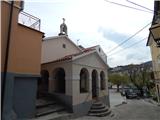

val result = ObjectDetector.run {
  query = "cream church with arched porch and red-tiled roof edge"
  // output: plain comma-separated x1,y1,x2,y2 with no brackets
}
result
41,20,109,114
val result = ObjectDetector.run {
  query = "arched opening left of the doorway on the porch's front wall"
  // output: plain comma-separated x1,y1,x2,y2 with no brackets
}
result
80,68,89,93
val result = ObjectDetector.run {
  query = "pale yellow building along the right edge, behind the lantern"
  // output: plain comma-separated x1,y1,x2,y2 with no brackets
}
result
147,1,160,102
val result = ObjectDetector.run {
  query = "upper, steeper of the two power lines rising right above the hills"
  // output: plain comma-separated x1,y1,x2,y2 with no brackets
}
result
107,22,152,54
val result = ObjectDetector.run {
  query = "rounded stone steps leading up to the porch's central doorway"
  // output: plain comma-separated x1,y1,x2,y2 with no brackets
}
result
88,100,111,117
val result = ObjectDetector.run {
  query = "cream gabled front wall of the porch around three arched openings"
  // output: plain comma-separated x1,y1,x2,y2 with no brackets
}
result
72,53,108,105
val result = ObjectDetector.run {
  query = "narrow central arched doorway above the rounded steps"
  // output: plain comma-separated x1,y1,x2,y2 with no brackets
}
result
92,69,98,98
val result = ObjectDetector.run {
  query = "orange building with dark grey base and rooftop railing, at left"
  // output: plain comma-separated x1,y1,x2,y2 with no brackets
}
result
1,1,44,120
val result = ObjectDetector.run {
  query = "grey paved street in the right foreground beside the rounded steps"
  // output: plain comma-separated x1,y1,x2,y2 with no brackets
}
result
72,99,160,120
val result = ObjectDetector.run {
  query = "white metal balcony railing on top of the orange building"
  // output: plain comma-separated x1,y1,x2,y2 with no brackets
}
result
18,11,41,31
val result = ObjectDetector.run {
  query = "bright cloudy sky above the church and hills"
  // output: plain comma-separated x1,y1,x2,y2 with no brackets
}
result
24,0,154,67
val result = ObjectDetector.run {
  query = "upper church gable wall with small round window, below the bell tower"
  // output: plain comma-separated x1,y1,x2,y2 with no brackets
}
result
41,36,80,63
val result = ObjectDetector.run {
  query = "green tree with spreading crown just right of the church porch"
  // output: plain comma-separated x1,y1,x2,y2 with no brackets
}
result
109,73,129,92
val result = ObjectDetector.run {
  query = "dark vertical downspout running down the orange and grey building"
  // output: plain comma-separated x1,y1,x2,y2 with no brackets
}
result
2,1,14,113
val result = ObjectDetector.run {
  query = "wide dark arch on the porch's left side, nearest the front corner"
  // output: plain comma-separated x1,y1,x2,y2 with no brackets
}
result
53,68,65,93
